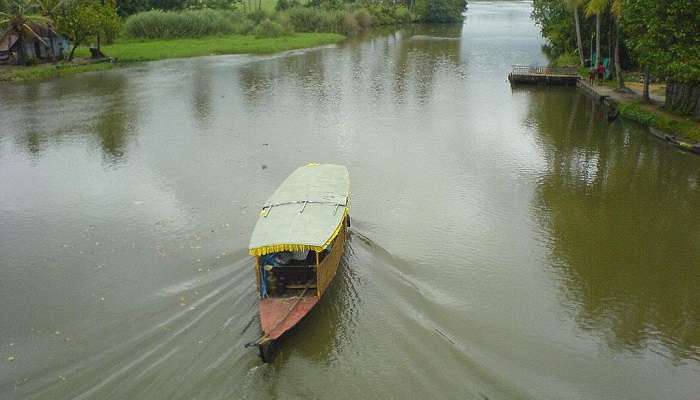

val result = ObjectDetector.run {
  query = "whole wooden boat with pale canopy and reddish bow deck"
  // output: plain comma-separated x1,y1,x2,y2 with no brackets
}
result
249,164,350,362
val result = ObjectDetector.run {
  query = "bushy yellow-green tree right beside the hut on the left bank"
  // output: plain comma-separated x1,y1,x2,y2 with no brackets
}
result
56,0,121,60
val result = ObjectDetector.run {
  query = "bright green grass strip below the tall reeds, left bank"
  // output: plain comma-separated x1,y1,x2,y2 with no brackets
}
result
76,33,345,63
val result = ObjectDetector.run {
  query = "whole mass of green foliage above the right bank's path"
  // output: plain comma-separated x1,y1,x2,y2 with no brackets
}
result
532,0,700,118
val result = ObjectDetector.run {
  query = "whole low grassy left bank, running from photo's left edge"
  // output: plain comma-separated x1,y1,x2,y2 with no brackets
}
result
0,33,345,82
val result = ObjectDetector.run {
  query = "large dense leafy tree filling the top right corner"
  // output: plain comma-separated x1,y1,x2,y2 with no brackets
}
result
622,0,700,118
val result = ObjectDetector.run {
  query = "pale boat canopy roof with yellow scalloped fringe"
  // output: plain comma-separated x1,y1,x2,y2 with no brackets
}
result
248,164,350,256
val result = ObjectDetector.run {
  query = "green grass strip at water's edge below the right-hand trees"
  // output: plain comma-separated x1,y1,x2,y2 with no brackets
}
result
619,102,700,143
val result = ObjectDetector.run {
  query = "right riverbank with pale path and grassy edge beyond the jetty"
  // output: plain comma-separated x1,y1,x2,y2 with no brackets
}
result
578,78,700,154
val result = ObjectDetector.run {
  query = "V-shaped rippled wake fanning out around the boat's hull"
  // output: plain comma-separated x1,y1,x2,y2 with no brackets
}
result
14,227,527,399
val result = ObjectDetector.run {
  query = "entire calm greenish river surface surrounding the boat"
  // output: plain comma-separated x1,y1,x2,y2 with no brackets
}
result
0,2,700,400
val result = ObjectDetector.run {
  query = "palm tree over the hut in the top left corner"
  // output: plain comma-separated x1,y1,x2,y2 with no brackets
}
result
0,0,49,64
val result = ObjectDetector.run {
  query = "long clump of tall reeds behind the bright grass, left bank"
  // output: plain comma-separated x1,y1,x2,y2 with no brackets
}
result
124,9,251,39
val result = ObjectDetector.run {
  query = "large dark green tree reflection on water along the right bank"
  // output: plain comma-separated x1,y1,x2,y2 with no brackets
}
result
528,90,700,360
